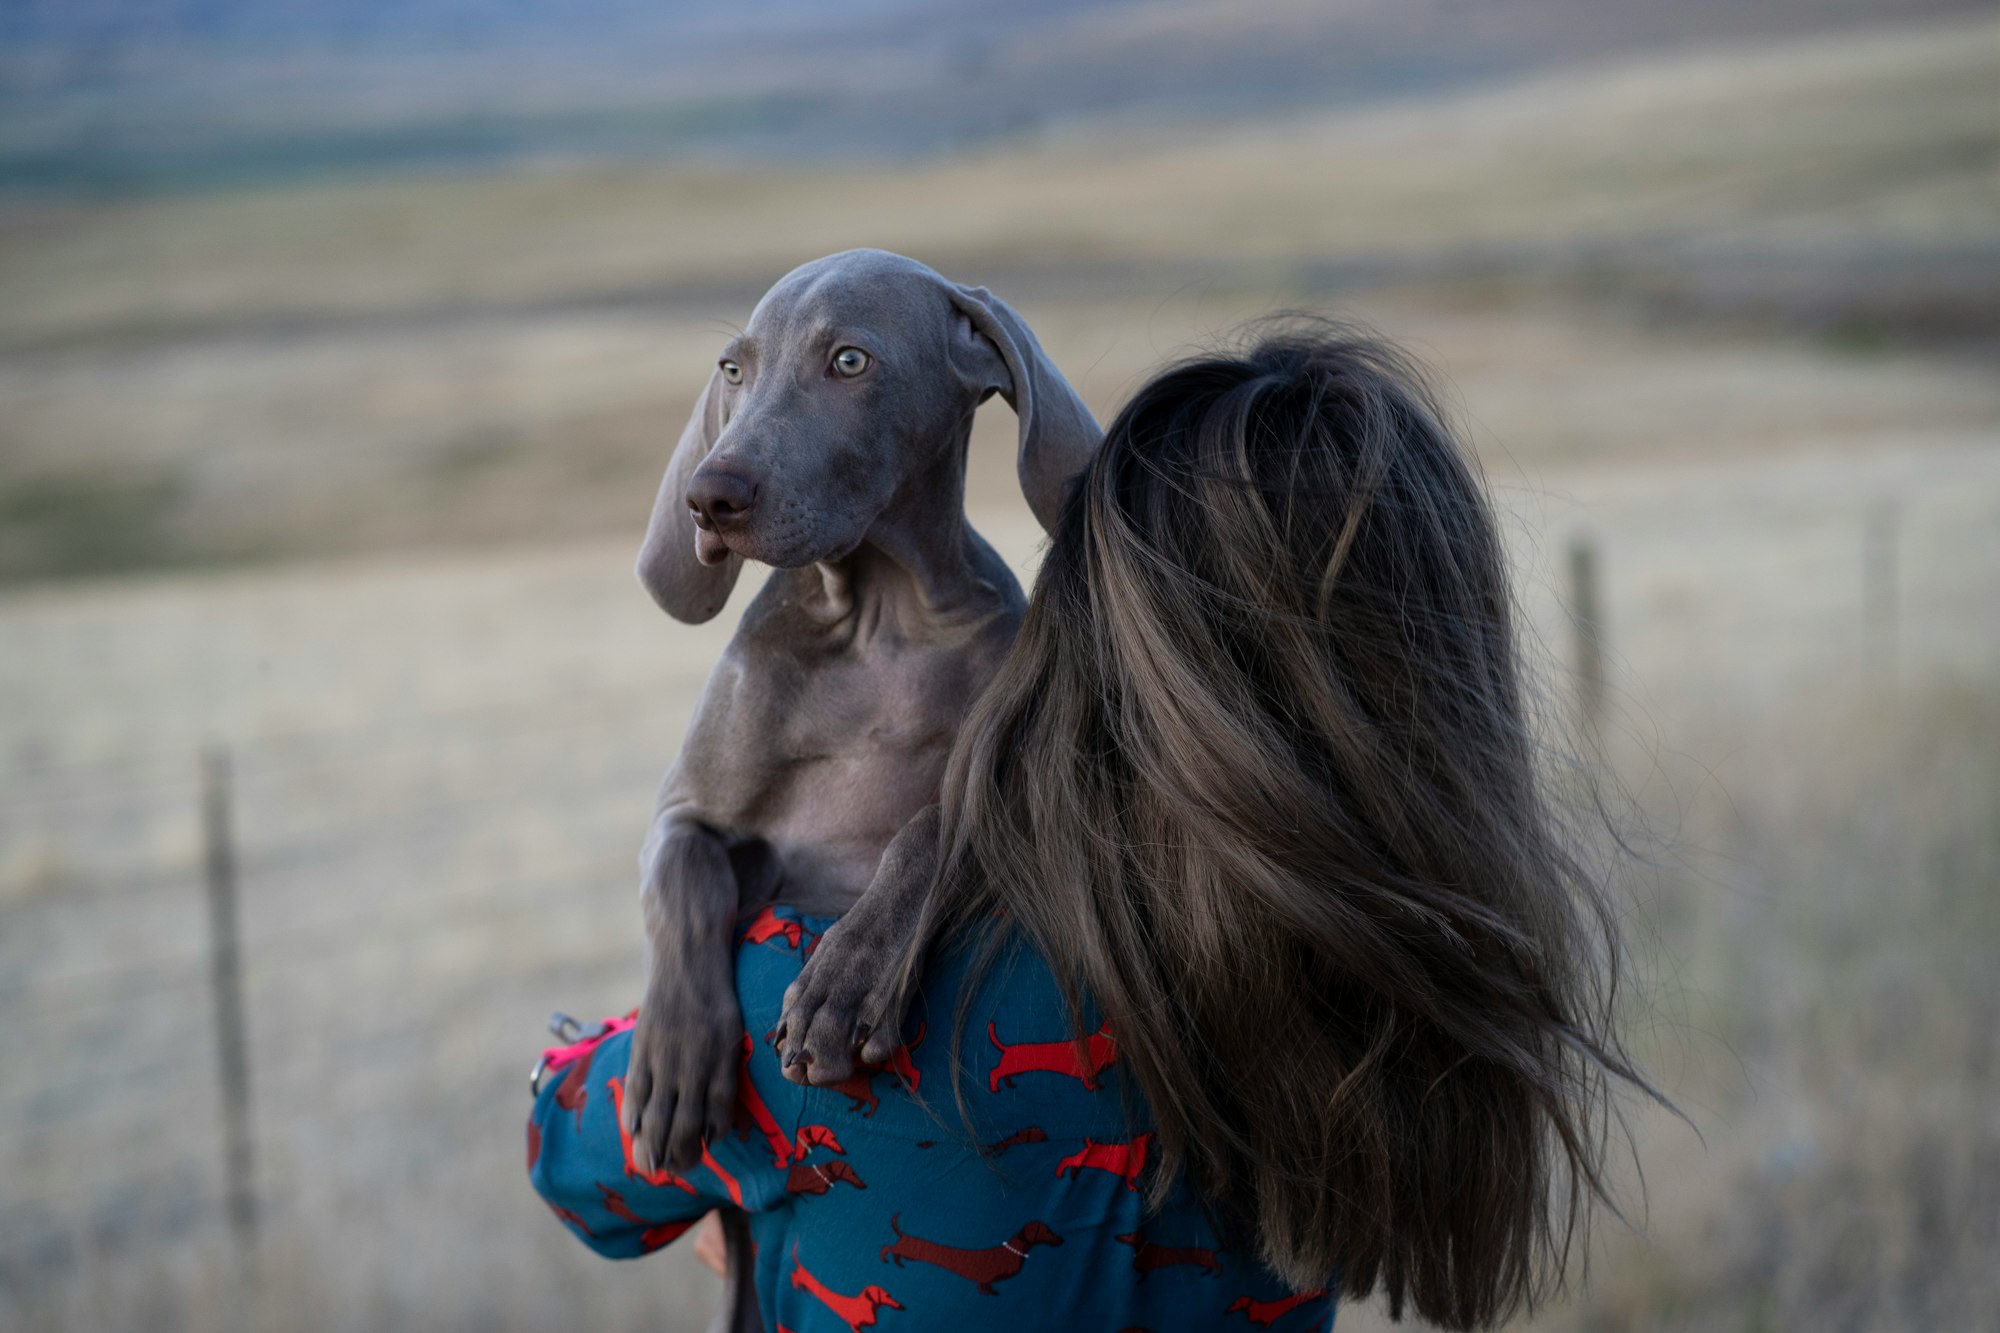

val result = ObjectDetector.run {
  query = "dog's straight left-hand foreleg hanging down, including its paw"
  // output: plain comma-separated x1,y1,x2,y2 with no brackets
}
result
624,813,744,1171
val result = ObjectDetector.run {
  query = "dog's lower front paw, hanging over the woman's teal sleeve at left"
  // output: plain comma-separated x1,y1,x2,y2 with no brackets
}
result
624,975,744,1173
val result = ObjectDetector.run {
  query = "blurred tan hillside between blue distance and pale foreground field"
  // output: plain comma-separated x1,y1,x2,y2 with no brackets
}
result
0,6,2000,578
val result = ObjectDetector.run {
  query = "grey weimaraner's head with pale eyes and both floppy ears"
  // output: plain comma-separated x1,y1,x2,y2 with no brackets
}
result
638,250,1102,622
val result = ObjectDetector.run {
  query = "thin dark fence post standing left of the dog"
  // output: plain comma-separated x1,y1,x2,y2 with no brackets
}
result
202,747,256,1259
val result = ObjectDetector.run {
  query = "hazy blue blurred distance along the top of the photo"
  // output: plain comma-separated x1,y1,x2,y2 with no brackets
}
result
0,0,1982,190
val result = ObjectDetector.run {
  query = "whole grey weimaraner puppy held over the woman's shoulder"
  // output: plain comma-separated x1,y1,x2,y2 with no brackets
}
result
624,250,1102,1317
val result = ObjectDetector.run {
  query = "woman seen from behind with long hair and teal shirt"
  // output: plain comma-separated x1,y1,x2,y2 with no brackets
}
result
536,324,1636,1331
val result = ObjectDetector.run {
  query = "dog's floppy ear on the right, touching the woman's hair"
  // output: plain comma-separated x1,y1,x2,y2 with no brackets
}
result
948,284,1104,532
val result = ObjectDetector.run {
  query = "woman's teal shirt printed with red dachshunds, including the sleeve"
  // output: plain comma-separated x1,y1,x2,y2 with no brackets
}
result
528,907,1332,1333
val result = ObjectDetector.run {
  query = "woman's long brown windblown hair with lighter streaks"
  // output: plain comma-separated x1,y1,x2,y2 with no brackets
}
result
912,322,1636,1327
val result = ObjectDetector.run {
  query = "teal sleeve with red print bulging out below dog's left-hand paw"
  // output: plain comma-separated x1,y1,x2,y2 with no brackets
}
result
528,1016,752,1259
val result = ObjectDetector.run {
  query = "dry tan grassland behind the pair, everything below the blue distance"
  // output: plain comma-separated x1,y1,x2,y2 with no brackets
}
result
0,16,2000,1331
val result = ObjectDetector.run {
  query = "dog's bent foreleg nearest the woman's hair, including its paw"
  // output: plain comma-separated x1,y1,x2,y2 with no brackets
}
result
776,805,938,1087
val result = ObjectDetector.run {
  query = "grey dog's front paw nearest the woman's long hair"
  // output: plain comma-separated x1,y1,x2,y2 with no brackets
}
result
772,915,908,1087
